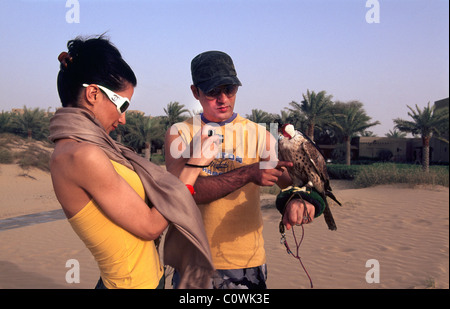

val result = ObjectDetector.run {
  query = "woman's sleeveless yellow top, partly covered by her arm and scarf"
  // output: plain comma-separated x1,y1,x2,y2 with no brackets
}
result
69,161,164,289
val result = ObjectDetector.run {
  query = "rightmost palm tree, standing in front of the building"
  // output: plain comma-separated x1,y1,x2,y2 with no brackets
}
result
394,102,448,172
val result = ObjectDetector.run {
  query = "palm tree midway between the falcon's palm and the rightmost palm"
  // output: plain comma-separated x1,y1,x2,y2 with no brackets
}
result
331,101,380,165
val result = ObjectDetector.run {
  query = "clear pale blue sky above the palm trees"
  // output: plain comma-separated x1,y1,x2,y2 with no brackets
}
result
0,0,449,136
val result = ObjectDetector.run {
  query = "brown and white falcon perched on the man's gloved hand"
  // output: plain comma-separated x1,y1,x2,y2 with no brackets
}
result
278,124,341,230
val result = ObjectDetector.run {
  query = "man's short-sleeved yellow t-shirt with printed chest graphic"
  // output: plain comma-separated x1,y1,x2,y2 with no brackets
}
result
172,114,266,269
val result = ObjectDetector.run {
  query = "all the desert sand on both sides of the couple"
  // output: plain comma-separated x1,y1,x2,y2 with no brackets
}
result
0,165,449,289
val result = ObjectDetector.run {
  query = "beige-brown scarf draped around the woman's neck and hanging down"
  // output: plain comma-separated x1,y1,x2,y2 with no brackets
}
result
49,107,214,288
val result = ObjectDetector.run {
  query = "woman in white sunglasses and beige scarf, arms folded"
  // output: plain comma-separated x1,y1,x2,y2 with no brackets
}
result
50,37,217,289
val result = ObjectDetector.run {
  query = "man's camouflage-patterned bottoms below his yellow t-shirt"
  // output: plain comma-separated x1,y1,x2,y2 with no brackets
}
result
172,264,267,289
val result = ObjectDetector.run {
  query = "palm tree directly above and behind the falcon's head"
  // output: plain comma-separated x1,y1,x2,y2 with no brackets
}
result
289,89,333,140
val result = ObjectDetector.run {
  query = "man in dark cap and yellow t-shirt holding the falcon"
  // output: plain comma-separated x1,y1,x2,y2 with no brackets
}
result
165,51,315,288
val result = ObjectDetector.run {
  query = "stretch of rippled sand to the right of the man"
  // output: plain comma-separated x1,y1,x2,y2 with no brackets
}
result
265,180,449,289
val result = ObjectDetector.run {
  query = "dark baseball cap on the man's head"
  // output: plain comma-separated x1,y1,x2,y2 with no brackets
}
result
191,51,242,93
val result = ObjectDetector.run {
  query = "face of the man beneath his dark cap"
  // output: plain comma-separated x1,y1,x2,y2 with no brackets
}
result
191,85,238,122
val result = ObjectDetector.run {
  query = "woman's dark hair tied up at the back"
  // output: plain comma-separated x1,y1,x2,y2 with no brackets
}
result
57,35,137,107
